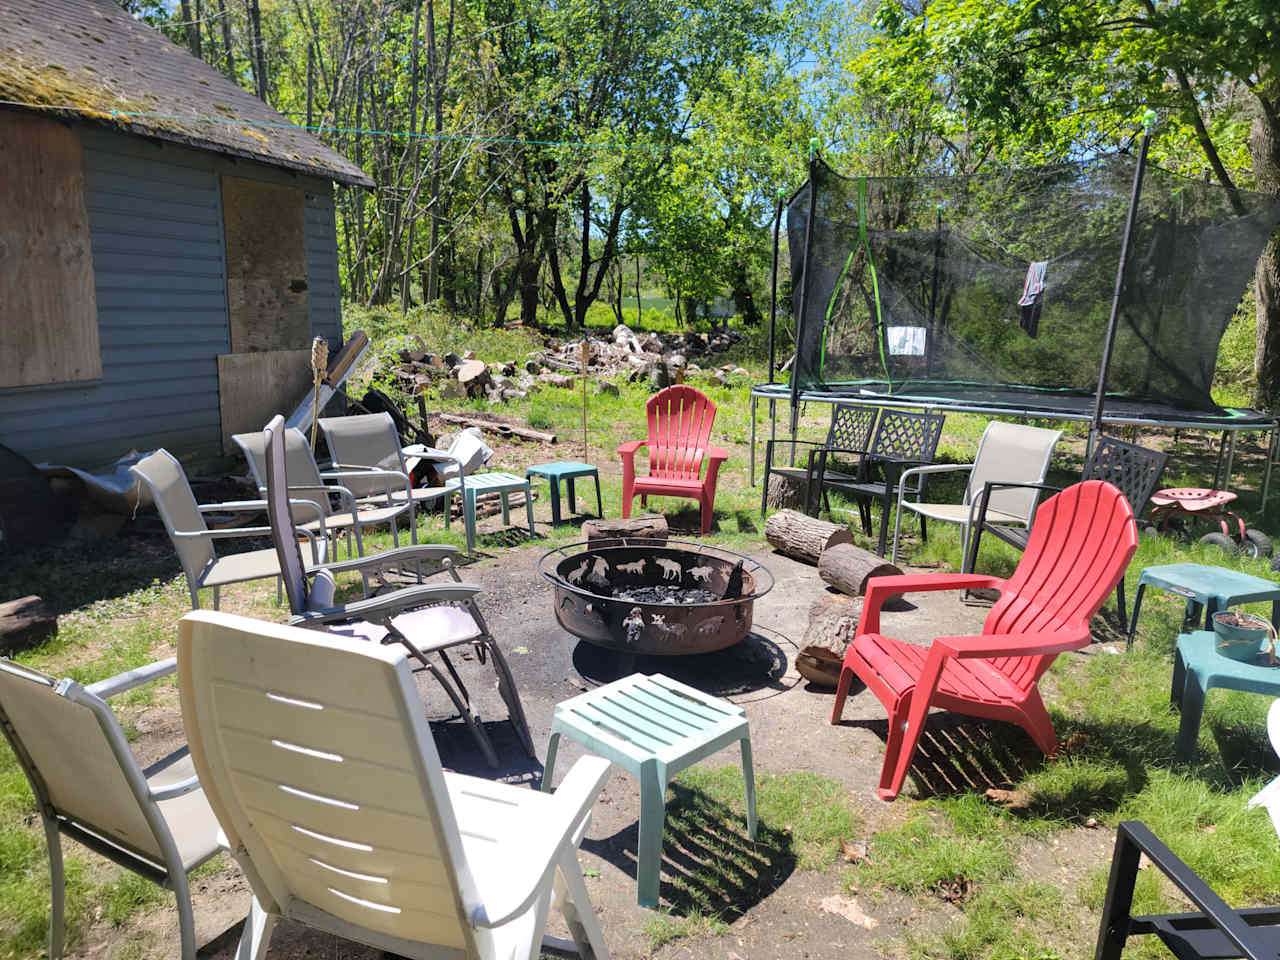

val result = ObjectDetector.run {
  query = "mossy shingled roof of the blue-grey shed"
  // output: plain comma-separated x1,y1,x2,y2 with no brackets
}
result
0,0,372,187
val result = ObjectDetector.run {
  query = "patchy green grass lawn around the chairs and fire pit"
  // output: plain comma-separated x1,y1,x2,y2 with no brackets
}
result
0,309,1280,960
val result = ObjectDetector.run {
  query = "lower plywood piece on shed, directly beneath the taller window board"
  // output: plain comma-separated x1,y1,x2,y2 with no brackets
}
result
218,349,311,456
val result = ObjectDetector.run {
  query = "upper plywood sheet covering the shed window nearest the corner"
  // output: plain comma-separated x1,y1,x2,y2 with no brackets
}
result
223,177,311,353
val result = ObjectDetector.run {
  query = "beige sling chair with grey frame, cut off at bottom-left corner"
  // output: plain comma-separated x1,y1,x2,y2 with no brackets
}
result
0,658,219,960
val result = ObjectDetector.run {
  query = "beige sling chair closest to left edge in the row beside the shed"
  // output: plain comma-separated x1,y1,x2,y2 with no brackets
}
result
129,449,325,609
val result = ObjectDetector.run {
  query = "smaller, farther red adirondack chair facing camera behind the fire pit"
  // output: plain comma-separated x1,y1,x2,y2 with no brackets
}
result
618,387,728,534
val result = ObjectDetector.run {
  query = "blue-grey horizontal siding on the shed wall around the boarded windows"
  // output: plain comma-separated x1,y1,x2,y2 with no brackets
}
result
0,128,342,466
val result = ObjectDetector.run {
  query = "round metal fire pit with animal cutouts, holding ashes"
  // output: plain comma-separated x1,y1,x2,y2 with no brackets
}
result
538,539,773,657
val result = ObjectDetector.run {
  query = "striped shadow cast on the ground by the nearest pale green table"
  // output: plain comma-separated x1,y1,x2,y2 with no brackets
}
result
582,781,797,923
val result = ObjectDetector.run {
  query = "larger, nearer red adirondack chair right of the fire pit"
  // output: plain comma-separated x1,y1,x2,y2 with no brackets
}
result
831,480,1138,800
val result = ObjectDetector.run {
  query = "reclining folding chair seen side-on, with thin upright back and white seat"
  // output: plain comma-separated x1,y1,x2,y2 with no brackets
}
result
262,416,534,767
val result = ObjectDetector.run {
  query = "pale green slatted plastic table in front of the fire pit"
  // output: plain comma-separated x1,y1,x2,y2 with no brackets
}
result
543,673,755,906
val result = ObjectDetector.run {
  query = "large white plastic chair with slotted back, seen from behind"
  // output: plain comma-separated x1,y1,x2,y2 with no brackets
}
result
178,612,609,960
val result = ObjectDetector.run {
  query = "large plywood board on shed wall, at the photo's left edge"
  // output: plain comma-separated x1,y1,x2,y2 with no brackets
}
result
0,115,102,387
